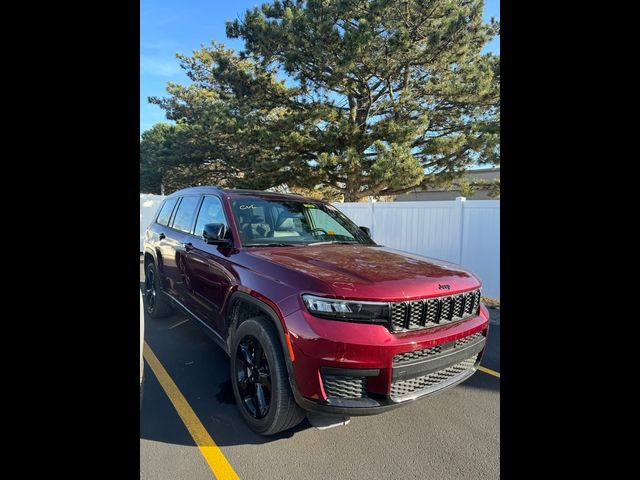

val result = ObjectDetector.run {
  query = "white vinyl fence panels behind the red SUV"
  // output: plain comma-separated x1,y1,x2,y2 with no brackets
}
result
140,194,500,299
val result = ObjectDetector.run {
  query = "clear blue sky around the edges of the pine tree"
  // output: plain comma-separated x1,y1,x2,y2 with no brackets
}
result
140,0,500,133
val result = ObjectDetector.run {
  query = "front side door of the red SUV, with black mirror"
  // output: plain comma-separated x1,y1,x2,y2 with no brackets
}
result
185,195,236,335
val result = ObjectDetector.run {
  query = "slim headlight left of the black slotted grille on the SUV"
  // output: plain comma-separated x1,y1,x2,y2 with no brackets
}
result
302,295,389,324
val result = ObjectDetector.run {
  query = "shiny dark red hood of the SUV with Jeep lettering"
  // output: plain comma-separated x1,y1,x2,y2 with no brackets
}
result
251,244,480,301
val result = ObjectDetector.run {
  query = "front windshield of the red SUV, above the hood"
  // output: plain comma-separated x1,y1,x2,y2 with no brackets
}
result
231,196,375,247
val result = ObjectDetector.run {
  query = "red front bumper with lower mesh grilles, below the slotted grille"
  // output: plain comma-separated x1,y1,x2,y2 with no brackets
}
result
286,306,489,415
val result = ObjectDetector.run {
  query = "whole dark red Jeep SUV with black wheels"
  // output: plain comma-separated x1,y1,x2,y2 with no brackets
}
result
144,187,489,435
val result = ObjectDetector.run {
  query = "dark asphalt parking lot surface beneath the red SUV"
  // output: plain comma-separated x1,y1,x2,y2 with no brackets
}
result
140,265,500,480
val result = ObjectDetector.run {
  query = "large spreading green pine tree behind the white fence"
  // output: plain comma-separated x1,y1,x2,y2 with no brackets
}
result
145,0,500,201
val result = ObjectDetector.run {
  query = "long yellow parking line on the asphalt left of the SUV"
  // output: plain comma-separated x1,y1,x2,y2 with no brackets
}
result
143,342,240,480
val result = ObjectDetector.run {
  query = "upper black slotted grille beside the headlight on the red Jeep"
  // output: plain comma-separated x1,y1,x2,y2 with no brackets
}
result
390,289,480,332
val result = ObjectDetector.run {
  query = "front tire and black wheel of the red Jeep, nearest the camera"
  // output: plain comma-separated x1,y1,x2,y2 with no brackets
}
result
230,317,305,435
